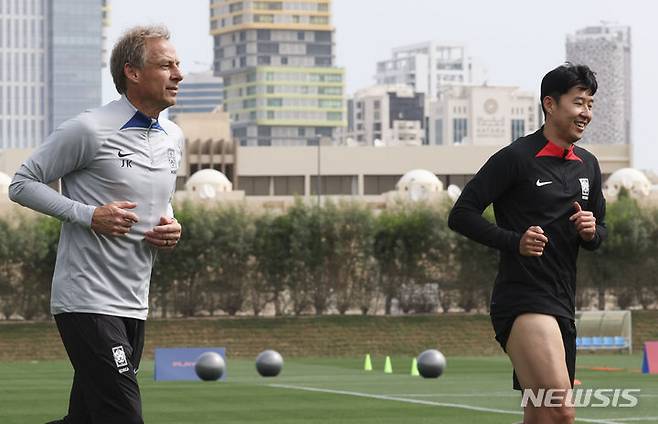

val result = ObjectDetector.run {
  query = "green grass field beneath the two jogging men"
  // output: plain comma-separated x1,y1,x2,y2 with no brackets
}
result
0,355,658,424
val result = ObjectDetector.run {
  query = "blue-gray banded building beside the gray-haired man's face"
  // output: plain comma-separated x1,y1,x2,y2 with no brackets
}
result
168,71,224,120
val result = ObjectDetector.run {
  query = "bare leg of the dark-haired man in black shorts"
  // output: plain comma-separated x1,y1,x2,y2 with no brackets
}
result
506,314,576,424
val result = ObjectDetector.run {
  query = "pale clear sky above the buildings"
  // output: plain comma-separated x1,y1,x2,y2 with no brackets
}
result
103,0,658,169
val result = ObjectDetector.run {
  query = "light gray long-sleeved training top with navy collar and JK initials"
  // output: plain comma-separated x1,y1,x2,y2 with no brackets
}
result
9,97,184,320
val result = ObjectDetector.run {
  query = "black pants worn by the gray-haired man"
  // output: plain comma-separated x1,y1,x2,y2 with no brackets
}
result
55,313,144,424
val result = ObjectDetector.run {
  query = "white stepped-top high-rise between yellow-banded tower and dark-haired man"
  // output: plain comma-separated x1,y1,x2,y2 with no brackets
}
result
375,41,485,100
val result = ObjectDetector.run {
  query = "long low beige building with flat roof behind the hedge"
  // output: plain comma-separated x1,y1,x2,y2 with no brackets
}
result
237,145,630,207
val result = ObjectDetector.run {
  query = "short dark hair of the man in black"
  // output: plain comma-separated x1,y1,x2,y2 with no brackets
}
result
540,62,599,116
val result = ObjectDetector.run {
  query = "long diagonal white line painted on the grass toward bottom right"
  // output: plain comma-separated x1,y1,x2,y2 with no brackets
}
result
269,384,640,424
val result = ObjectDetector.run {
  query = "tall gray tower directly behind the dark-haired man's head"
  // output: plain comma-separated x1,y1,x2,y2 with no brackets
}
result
566,22,632,144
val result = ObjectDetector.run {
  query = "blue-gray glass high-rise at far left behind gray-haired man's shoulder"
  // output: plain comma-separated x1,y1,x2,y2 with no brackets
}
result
0,0,106,148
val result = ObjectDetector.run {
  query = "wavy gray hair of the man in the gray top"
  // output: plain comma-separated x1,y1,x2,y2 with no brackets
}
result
110,25,169,94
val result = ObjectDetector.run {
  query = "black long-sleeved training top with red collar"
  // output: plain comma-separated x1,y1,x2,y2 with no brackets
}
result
448,127,606,319
